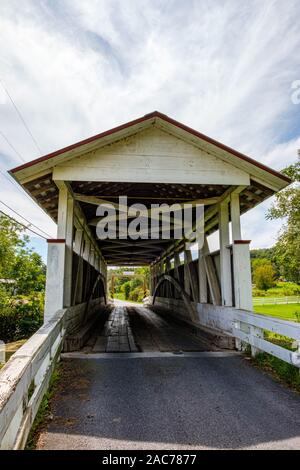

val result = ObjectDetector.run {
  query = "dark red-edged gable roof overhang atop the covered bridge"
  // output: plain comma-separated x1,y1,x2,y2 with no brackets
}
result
9,111,291,189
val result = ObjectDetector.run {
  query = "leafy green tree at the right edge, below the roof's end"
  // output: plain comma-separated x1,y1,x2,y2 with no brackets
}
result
267,155,300,284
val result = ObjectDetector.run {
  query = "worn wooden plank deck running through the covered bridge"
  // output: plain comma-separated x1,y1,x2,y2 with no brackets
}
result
82,301,216,354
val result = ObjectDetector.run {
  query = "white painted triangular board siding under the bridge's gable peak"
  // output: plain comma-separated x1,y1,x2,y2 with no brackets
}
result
53,127,249,185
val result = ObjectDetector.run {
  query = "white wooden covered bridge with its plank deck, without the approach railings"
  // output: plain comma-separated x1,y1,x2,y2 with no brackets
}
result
11,112,289,352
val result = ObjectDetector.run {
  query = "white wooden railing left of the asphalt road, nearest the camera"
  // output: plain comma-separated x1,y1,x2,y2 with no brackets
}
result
0,310,66,449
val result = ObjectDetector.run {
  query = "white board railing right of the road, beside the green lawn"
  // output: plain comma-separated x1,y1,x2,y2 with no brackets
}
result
233,311,300,368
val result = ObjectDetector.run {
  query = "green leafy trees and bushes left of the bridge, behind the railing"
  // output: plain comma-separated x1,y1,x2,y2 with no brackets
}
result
0,215,46,342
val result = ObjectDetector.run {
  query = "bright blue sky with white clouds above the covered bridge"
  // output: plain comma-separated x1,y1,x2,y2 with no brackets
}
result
0,0,300,259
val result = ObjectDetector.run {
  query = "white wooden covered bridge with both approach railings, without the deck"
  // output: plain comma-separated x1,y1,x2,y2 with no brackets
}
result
0,111,300,447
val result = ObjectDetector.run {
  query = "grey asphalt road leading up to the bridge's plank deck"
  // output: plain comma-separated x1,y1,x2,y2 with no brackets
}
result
38,353,300,450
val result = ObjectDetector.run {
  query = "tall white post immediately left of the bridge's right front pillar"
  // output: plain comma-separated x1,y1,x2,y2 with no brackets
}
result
219,201,232,307
